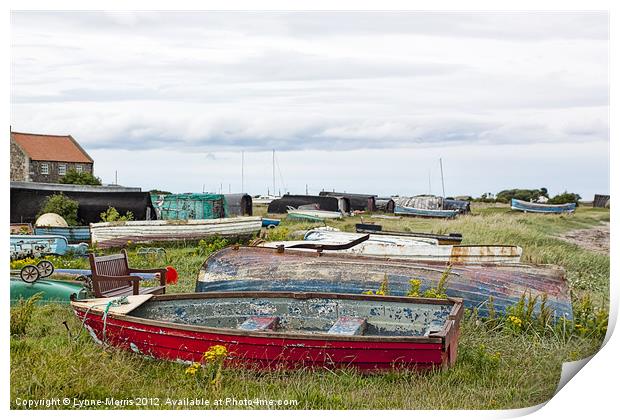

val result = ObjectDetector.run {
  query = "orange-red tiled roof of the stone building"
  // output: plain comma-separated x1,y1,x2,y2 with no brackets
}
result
11,131,93,163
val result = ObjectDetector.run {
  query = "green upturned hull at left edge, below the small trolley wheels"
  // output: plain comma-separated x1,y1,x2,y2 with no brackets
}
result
11,278,86,305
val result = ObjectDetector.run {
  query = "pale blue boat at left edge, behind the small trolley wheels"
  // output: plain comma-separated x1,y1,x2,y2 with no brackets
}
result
11,235,88,259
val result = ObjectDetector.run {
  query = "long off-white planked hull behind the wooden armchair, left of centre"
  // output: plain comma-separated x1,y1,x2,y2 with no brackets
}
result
90,217,261,248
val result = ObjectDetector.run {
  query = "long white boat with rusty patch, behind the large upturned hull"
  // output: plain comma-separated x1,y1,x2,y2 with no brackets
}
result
258,230,523,263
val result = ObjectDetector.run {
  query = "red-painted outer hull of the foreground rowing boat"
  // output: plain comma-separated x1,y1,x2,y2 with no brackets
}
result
72,293,462,371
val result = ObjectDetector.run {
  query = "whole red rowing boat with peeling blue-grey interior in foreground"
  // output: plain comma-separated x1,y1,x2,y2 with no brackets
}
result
71,292,463,370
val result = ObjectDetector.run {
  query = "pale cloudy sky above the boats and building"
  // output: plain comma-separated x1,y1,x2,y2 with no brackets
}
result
11,12,609,198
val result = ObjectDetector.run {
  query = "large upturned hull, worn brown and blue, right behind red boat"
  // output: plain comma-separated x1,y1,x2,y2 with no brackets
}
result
196,247,573,319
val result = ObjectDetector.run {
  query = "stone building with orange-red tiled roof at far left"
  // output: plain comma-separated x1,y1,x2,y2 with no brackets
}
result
10,131,94,183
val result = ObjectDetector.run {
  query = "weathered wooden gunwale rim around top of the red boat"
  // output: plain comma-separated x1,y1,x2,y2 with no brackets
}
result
71,291,464,348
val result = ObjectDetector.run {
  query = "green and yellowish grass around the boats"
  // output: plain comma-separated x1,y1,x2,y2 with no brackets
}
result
10,206,609,409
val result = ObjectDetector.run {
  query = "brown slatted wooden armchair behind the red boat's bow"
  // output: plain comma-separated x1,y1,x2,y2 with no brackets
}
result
88,249,166,298
